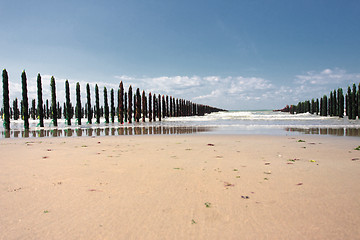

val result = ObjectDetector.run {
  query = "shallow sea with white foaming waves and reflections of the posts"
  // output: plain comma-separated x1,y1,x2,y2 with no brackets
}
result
0,110,360,138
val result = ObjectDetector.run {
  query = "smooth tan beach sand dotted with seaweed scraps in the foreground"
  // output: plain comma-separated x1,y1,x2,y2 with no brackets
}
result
0,135,360,240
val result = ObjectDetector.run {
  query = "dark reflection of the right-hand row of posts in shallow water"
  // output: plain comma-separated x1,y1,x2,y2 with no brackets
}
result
285,127,360,137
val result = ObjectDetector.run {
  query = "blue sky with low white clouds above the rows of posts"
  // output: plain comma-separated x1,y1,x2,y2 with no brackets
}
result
0,0,360,110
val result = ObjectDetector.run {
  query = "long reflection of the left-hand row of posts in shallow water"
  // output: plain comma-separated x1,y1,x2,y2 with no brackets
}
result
2,126,212,138
